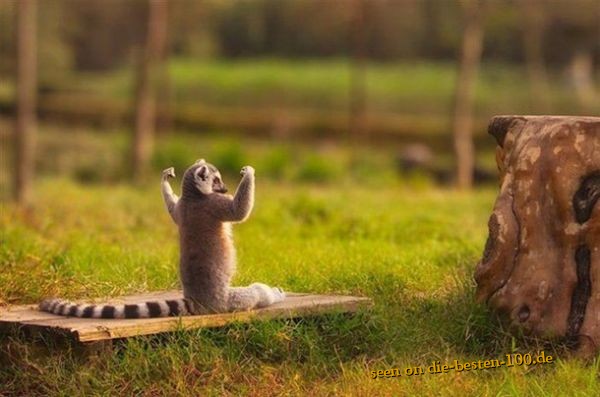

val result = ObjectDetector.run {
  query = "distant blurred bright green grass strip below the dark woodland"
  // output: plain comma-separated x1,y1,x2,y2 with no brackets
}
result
17,58,600,119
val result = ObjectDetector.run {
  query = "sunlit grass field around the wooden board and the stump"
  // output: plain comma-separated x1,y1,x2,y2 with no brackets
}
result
0,154,600,396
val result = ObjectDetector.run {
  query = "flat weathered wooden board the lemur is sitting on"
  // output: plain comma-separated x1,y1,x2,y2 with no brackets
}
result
0,291,372,342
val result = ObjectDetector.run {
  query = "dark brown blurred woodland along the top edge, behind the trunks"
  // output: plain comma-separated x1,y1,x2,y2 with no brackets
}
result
0,0,600,73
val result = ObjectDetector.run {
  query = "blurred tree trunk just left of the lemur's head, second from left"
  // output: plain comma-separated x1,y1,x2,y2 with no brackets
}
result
132,0,168,182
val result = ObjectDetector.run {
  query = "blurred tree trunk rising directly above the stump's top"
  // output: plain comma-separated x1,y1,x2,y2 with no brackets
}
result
521,0,549,112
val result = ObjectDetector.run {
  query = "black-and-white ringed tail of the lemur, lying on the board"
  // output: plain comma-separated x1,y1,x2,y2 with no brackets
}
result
39,298,192,318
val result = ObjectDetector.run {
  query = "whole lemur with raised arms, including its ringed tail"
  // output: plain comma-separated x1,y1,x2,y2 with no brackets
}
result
39,159,285,318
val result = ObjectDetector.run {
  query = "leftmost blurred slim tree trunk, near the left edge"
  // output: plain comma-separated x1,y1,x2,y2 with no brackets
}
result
14,0,37,206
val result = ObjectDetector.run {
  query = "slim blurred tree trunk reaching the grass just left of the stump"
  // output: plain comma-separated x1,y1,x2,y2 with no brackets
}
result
453,0,483,189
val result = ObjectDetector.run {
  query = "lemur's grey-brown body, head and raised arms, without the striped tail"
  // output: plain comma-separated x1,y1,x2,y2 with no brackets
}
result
163,160,285,314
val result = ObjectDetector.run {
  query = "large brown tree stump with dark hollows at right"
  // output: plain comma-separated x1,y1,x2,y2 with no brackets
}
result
475,116,600,356
